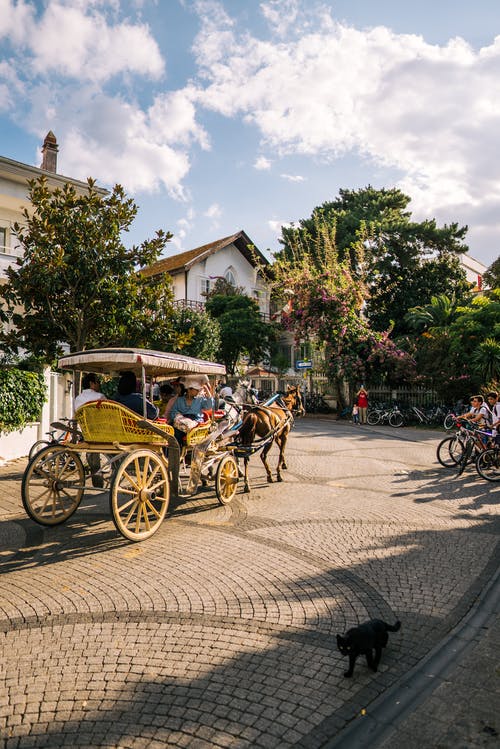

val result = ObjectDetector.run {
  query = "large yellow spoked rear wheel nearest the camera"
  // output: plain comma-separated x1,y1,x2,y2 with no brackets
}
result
110,449,170,541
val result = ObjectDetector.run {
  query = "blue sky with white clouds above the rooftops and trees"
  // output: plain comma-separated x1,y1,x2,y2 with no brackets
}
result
0,0,500,265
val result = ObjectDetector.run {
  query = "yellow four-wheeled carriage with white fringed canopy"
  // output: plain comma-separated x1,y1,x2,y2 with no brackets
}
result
22,348,239,541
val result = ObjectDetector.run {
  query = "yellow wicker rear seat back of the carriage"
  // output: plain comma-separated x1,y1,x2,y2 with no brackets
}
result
75,400,174,444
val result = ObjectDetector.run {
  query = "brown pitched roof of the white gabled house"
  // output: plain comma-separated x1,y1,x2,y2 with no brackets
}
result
141,231,269,277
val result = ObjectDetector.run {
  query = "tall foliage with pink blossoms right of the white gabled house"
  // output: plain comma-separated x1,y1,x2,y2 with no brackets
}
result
273,220,413,400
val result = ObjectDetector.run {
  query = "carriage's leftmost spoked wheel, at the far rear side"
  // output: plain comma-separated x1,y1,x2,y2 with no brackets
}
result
21,446,85,525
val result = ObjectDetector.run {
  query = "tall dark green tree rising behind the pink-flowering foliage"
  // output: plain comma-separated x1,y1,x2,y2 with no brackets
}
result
281,186,470,337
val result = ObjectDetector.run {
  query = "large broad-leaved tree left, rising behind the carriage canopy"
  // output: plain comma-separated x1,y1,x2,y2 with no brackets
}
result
3,177,176,362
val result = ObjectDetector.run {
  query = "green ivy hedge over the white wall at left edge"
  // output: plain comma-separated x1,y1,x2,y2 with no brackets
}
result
0,368,47,433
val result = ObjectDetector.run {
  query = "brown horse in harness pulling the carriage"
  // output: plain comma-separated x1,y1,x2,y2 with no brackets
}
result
238,387,305,492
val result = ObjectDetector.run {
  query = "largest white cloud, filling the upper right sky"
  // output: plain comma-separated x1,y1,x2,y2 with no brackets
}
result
190,2,500,248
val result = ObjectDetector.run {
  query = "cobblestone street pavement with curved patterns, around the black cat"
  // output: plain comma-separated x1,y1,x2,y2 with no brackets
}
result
0,418,500,749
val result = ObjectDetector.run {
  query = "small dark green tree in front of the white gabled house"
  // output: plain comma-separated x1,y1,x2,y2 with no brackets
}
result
206,290,276,374
